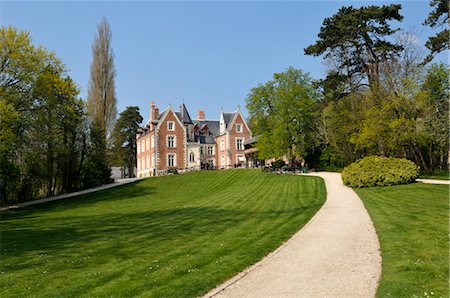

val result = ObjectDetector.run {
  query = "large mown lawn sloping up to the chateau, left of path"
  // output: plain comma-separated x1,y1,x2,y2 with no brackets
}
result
0,170,326,297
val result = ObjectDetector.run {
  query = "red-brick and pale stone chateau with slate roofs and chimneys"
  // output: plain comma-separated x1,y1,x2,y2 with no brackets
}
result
136,102,251,177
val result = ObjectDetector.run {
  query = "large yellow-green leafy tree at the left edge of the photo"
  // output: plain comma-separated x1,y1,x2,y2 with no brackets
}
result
0,27,87,204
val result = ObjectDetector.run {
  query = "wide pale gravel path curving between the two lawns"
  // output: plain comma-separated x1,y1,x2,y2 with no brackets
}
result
205,173,381,297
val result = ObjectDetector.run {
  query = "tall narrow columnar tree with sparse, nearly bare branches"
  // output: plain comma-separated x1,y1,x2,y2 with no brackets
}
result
87,18,117,144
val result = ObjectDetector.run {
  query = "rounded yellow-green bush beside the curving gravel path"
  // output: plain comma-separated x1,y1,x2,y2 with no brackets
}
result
342,156,419,187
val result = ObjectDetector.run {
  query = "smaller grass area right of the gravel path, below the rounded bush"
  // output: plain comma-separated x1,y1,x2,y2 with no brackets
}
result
355,183,449,297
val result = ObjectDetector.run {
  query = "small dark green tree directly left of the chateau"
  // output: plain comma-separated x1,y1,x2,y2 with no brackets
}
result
114,107,143,177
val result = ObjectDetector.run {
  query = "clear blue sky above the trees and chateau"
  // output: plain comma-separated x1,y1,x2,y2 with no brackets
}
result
0,1,448,119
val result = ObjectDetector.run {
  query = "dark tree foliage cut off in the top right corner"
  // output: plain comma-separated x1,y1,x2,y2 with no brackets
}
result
423,0,450,63
